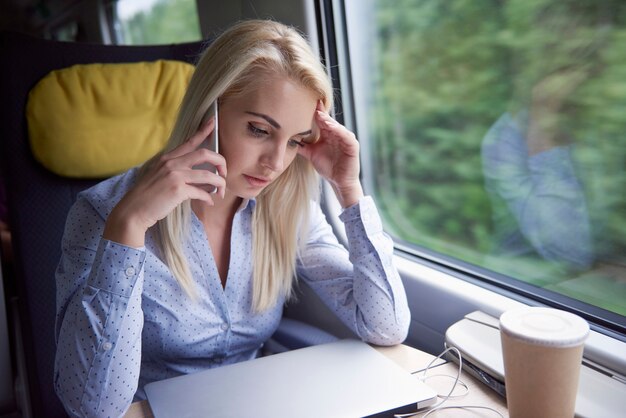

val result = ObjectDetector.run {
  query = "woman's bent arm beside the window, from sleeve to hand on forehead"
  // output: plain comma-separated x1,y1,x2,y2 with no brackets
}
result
299,104,410,345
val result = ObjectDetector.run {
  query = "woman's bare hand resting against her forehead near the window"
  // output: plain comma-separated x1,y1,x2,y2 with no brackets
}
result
298,102,363,208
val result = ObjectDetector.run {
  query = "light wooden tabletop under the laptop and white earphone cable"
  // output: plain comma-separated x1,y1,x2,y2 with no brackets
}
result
124,344,509,418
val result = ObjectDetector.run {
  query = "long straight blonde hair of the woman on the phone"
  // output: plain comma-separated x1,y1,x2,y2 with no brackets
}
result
141,20,332,312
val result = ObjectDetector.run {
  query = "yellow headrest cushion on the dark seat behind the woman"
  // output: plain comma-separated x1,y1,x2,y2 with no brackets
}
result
26,61,194,178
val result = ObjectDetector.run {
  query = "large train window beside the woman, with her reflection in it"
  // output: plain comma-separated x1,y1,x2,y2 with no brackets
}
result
342,0,626,333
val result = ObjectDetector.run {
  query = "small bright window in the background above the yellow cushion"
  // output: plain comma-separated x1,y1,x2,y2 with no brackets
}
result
112,0,202,45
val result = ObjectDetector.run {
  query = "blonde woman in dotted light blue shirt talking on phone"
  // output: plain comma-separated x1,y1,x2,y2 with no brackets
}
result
55,21,409,416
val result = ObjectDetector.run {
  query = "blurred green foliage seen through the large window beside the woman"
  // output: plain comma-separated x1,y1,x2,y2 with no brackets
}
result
369,0,626,315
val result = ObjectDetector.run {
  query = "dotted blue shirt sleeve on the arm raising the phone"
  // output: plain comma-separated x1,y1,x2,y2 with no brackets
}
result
55,198,145,417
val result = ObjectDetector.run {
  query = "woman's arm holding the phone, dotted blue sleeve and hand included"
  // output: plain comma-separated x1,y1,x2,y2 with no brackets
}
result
55,119,226,416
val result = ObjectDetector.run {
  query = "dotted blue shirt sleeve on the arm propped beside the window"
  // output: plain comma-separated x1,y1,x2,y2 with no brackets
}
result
298,197,410,345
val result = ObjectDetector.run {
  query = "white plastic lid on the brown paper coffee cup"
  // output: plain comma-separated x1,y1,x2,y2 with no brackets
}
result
500,306,589,347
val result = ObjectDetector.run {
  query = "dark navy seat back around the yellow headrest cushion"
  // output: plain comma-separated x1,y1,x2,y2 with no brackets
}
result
0,32,203,417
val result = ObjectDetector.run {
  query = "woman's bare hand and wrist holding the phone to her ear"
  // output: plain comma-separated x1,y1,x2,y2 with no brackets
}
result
103,118,226,247
